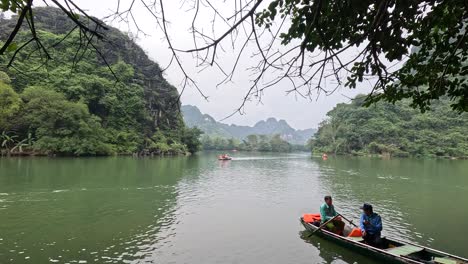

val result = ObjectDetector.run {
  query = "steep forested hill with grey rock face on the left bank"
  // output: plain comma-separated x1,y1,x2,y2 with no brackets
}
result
0,8,200,155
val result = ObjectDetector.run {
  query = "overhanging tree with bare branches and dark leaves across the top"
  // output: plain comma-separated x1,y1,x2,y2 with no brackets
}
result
0,0,468,112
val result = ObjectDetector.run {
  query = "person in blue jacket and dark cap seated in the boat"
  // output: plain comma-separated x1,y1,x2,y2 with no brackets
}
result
359,203,382,248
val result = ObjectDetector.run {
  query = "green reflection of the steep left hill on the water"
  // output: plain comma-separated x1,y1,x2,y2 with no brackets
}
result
0,157,199,263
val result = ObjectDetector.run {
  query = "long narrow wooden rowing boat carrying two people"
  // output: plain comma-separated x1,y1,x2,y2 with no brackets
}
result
300,217,468,264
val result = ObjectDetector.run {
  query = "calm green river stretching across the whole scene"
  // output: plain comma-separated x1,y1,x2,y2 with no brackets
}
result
0,153,468,264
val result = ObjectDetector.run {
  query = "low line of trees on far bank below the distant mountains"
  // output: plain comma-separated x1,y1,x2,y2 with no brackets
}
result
201,134,296,152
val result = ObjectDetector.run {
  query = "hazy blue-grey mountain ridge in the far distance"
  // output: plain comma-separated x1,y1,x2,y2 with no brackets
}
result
181,105,316,144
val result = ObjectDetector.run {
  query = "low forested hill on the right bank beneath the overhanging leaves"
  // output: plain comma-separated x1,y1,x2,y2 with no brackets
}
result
311,96,468,157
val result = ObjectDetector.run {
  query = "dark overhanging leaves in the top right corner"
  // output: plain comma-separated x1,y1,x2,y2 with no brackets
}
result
257,0,468,112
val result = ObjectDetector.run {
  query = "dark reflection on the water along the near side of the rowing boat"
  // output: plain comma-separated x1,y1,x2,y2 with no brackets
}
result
299,231,379,264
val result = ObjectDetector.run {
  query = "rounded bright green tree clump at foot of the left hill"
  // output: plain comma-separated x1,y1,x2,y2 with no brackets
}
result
21,86,114,155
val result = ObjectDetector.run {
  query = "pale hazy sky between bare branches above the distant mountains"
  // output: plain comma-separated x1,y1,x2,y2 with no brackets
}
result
38,0,366,129
